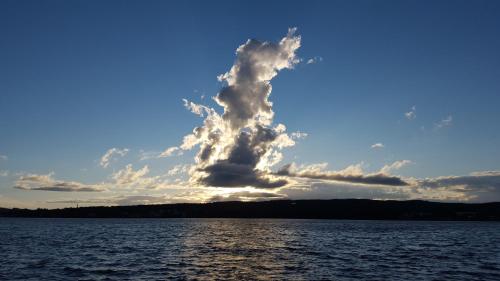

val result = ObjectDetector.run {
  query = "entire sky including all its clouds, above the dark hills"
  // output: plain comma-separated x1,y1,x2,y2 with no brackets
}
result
0,1,500,208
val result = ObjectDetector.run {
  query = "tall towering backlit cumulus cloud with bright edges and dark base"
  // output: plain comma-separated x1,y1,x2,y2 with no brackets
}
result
166,29,301,188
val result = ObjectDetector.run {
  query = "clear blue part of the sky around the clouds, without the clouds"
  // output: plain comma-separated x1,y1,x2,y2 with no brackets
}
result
0,1,500,207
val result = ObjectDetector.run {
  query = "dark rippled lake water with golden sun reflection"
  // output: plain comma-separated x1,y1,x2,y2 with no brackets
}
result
0,218,500,281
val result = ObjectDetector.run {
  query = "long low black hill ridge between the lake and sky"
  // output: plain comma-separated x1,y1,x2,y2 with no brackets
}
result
0,199,500,221
